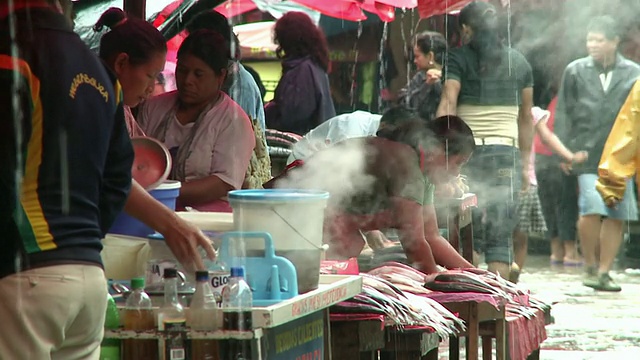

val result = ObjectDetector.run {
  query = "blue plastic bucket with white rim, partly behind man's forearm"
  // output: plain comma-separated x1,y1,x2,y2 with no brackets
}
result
109,180,180,237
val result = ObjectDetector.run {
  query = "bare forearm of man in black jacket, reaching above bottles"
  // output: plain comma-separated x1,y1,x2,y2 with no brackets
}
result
125,180,215,271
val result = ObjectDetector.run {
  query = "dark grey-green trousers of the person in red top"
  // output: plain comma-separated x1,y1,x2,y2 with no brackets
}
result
536,154,578,241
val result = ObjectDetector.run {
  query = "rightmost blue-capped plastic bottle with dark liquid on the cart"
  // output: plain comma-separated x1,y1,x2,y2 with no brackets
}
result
222,267,253,360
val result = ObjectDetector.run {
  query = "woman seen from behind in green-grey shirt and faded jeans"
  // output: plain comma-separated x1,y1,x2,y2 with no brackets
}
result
438,1,533,277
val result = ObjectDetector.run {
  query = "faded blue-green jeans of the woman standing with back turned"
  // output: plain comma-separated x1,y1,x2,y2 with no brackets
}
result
463,145,522,265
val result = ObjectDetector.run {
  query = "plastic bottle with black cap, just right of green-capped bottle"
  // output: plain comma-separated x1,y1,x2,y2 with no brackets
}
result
158,269,189,360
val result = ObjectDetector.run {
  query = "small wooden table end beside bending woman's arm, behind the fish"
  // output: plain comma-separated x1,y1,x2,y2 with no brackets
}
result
435,193,478,263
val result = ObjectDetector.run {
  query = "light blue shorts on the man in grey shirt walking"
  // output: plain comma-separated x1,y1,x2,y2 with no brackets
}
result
578,174,638,221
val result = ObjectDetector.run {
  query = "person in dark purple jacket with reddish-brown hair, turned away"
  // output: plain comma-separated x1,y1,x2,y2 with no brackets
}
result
265,11,336,135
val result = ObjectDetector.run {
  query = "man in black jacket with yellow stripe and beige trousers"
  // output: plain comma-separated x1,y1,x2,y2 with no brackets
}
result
0,0,133,359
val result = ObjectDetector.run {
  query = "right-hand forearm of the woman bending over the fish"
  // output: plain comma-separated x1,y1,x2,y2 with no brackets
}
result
422,205,474,269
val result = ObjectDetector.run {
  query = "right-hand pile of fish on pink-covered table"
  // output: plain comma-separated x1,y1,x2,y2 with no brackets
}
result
424,268,548,319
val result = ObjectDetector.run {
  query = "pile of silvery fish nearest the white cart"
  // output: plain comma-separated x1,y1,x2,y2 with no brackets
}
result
332,274,465,339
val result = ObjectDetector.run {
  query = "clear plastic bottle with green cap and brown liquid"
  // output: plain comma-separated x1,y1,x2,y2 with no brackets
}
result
122,278,158,360
